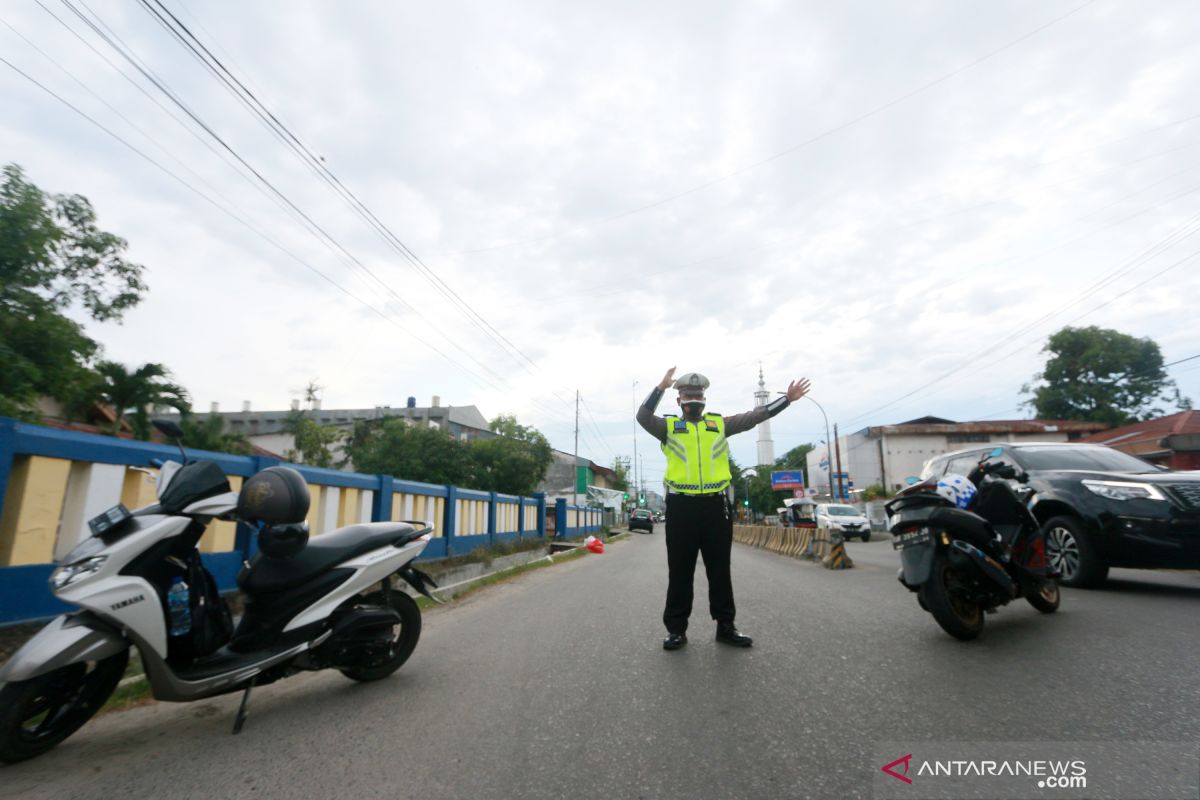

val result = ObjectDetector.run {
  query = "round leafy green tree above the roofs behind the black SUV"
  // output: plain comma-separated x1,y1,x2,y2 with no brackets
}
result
1021,325,1190,426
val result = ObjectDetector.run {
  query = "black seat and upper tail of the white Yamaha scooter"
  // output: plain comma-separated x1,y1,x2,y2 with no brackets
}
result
238,522,427,595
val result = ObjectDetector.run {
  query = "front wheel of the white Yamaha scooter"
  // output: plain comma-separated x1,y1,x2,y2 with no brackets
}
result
0,650,130,763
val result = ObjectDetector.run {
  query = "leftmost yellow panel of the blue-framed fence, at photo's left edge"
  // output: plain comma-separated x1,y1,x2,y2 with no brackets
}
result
0,456,71,566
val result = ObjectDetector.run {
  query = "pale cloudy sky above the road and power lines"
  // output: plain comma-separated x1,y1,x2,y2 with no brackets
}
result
0,0,1200,485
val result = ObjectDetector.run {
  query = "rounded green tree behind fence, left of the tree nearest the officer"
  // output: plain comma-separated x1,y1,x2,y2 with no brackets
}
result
346,417,470,486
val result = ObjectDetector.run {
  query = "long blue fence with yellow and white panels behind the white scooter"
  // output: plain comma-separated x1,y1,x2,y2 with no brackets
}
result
0,417,602,625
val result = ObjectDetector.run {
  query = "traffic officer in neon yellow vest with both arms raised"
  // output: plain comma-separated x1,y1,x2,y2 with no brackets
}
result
637,367,809,650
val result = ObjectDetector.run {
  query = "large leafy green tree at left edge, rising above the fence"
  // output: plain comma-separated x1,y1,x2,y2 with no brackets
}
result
0,164,146,416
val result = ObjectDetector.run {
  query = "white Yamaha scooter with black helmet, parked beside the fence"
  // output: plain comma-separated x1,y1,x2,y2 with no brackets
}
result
0,422,437,762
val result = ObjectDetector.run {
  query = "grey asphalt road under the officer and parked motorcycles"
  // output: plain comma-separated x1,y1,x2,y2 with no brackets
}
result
0,525,1200,800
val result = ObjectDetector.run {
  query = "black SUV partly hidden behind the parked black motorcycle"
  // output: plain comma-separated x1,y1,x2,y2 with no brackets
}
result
922,443,1200,587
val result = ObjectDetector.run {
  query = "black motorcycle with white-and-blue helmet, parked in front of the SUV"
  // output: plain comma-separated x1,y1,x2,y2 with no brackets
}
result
886,451,1060,640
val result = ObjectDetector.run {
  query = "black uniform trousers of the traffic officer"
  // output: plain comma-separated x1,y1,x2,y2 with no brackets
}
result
662,494,736,633
